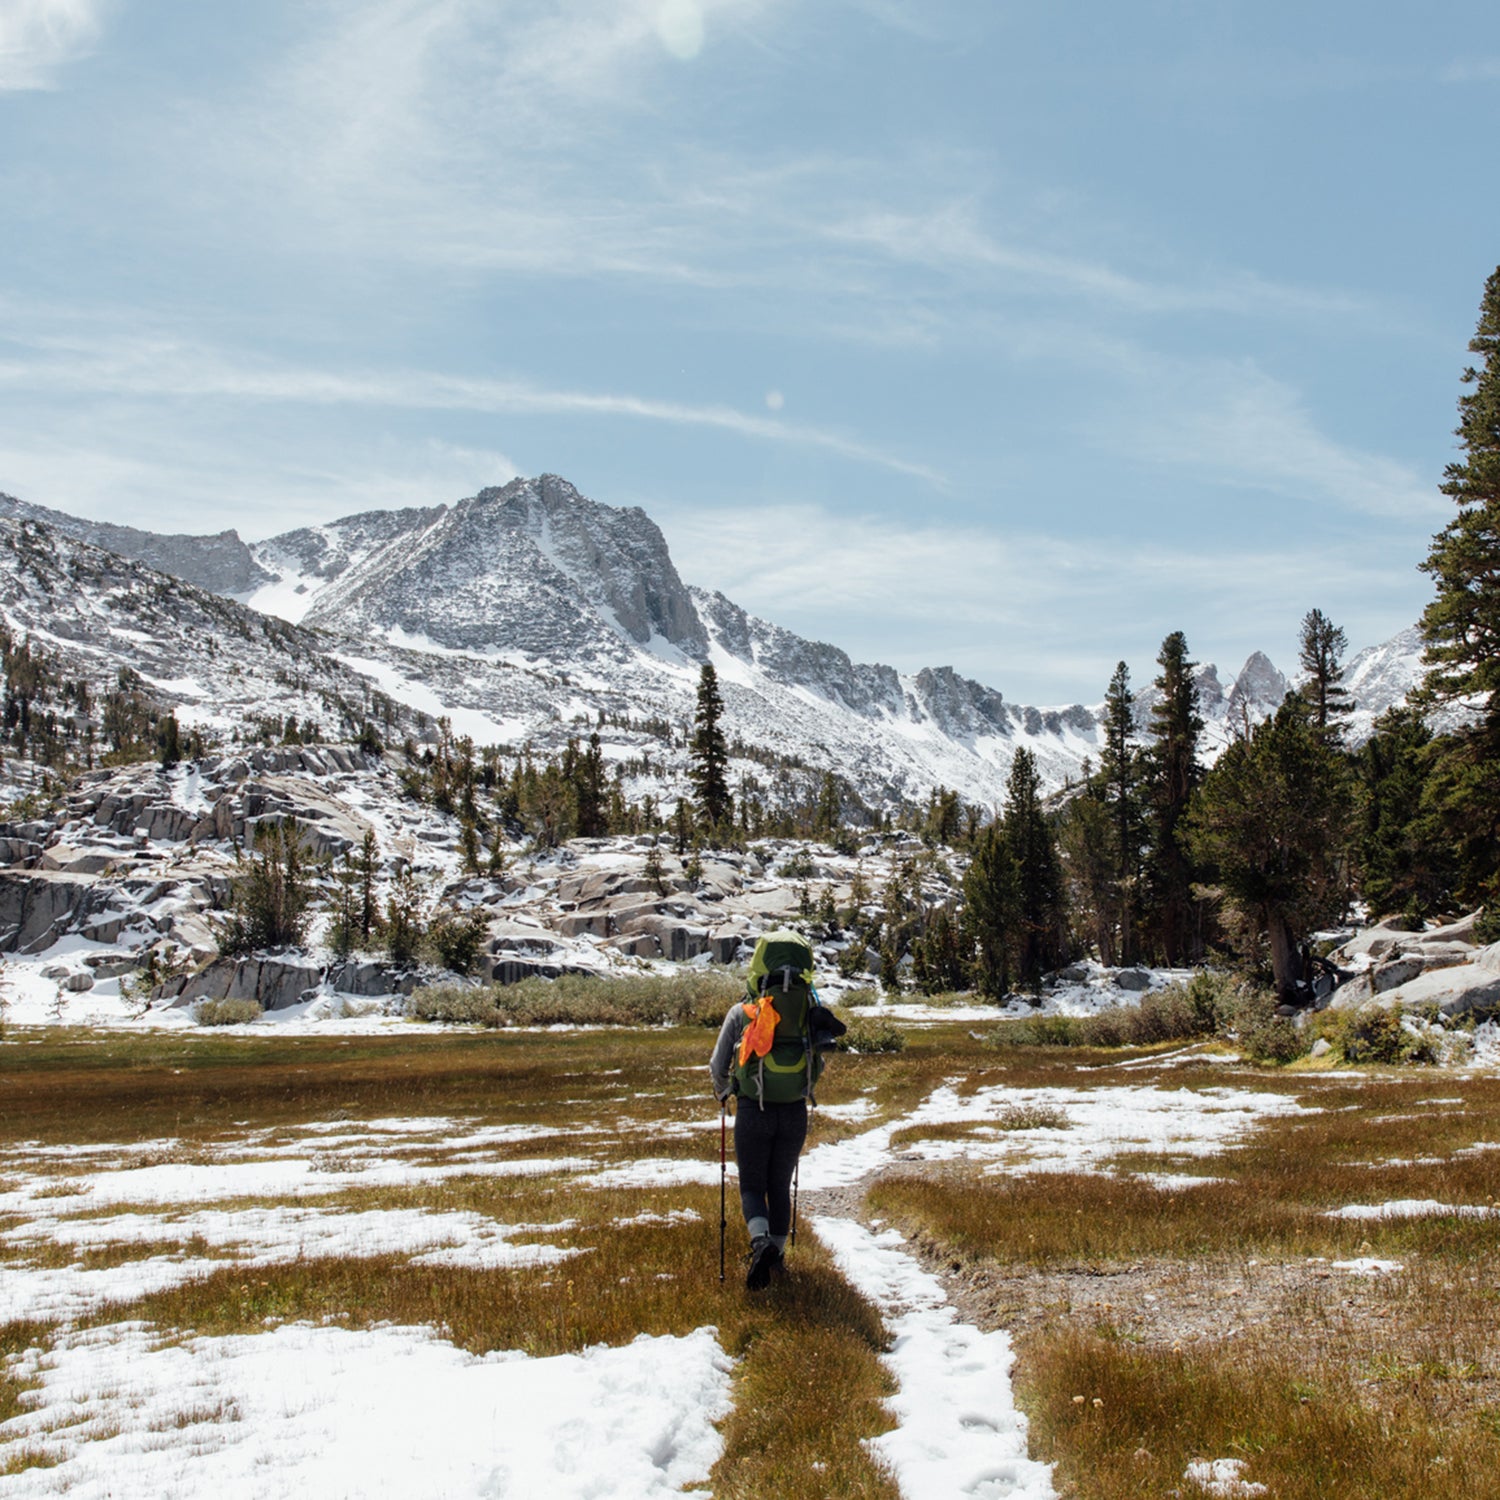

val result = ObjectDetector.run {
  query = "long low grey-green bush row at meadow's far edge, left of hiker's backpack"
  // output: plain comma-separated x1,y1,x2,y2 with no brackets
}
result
407,969,744,1028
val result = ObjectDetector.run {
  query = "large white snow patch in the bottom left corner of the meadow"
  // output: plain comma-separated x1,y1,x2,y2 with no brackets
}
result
5,1323,731,1500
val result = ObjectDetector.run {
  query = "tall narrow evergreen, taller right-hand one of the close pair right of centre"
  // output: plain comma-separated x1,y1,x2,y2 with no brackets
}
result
1146,630,1203,965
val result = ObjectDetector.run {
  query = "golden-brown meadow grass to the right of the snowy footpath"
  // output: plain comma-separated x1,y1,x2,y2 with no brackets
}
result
869,1058,1500,1500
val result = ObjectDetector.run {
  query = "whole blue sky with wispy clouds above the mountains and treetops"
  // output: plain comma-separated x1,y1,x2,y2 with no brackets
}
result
0,0,1500,702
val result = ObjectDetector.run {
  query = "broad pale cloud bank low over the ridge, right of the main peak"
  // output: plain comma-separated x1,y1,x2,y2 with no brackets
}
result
653,504,1424,704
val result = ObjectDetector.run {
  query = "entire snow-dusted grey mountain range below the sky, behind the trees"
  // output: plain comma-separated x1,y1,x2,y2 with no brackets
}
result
0,474,1421,806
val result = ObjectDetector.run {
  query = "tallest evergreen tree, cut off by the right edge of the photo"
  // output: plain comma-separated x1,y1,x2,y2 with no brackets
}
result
1422,267,1500,906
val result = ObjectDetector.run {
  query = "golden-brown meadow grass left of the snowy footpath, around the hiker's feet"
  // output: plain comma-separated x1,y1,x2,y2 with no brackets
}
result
0,1028,896,1500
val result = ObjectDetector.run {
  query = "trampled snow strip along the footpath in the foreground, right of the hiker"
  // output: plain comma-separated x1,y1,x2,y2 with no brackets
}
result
816,1218,1056,1500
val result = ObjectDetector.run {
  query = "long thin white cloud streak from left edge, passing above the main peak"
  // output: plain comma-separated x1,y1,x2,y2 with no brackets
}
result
0,338,944,486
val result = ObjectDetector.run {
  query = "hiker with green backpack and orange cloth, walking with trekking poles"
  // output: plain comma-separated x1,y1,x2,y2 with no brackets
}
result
708,929,845,1290
